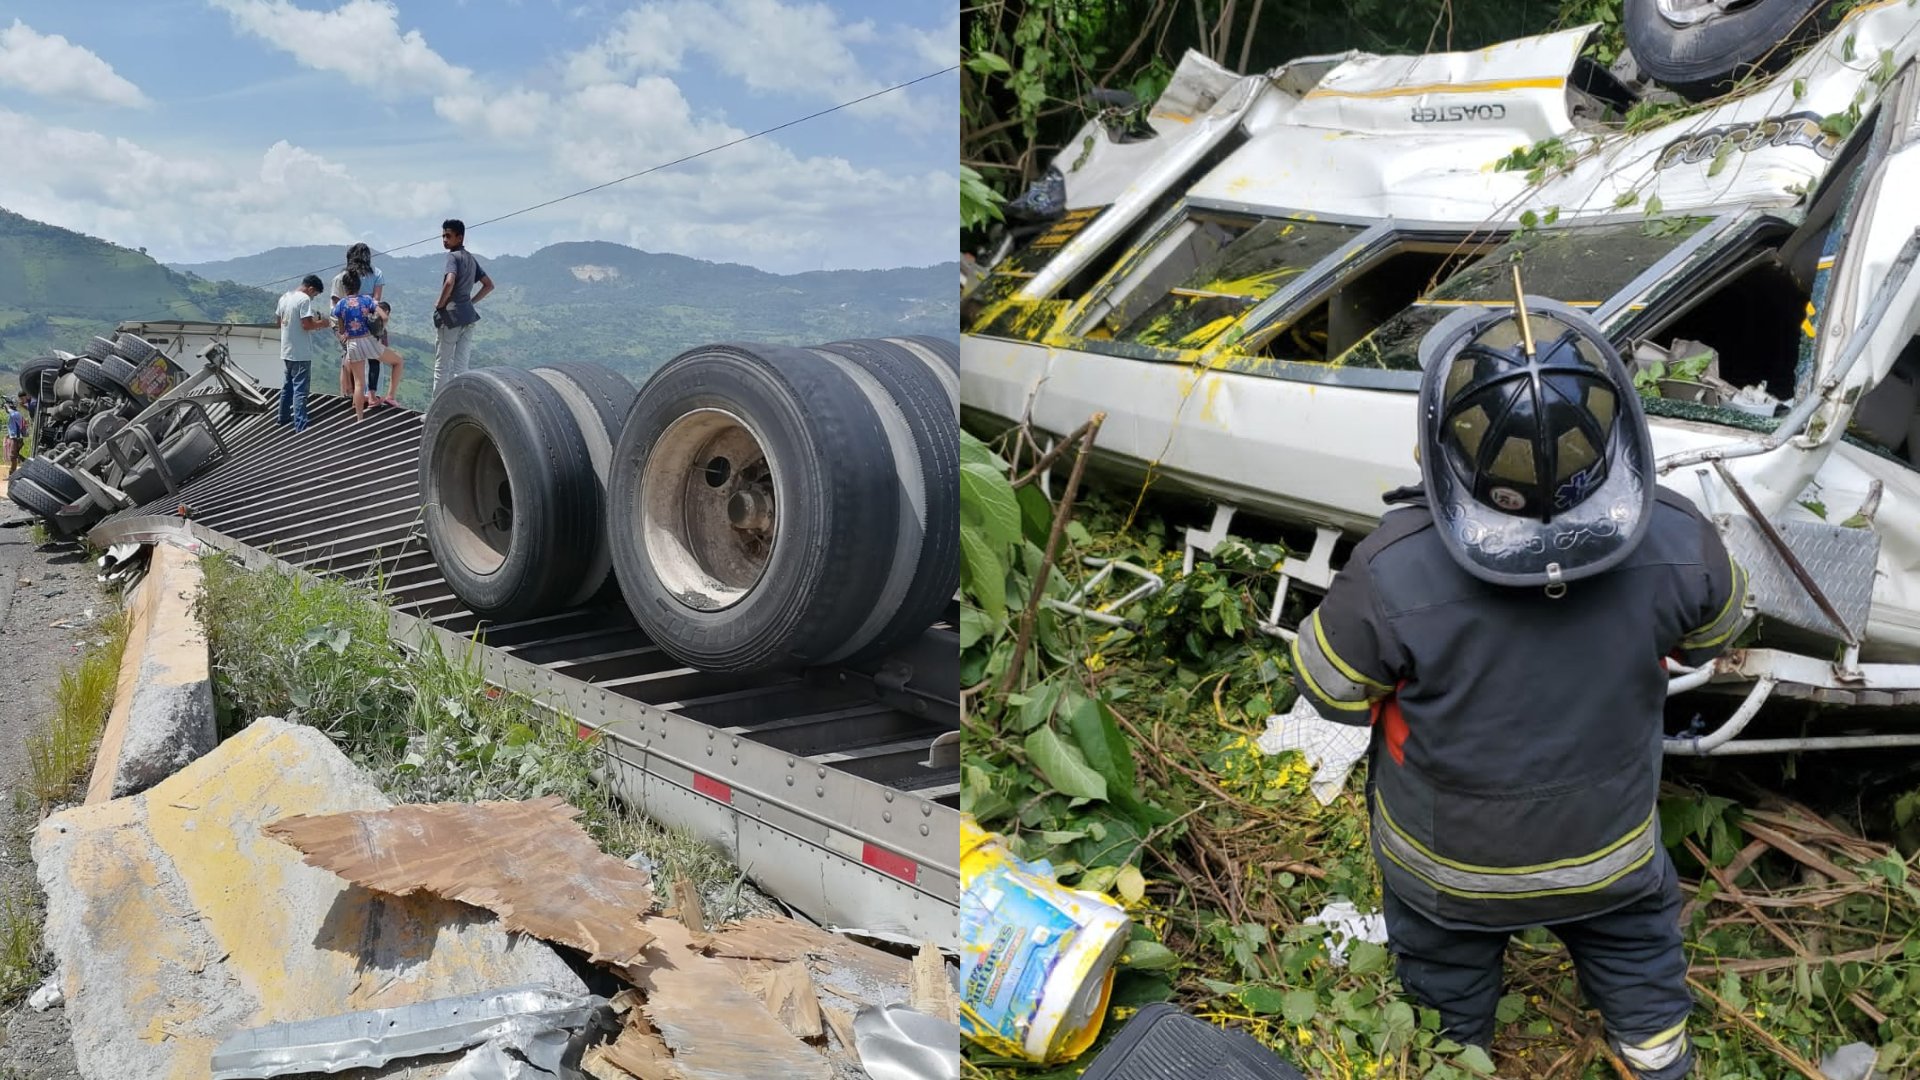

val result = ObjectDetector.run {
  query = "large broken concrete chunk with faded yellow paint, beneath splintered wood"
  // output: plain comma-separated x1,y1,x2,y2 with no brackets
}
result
33,717,586,1080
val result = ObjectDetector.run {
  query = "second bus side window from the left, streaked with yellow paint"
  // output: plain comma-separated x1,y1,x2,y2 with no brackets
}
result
1110,213,1361,348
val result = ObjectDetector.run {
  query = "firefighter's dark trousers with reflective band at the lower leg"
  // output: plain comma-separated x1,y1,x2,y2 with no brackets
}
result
1382,849,1693,1080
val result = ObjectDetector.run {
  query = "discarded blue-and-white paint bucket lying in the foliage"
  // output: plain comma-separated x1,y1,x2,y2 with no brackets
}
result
960,815,1129,1065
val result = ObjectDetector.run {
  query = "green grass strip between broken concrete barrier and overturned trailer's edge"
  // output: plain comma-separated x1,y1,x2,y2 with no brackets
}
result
198,555,772,919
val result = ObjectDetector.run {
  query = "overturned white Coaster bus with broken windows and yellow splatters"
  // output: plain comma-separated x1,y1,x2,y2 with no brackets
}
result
960,0,1920,753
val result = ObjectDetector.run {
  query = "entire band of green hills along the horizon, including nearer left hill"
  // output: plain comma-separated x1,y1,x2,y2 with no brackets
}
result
0,209,960,388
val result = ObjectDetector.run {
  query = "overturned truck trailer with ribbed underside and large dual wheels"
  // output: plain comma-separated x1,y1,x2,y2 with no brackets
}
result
86,338,960,947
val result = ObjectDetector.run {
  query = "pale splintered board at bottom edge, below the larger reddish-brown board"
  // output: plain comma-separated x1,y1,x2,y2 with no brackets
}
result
626,919,837,1080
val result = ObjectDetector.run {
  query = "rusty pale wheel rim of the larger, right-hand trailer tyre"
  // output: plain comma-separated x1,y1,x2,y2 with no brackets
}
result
637,409,780,611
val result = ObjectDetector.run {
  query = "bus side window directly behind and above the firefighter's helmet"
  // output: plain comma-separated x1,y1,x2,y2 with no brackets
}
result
1334,217,1711,371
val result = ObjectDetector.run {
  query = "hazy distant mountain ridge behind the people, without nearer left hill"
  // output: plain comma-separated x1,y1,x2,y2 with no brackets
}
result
175,242,960,380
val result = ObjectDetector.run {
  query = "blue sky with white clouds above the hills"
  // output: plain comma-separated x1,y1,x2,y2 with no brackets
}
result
0,0,958,271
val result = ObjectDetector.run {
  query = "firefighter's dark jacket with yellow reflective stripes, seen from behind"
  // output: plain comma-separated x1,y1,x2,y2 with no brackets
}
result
1292,488,1747,930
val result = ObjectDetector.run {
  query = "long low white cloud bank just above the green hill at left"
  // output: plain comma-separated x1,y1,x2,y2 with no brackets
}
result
0,110,451,261
